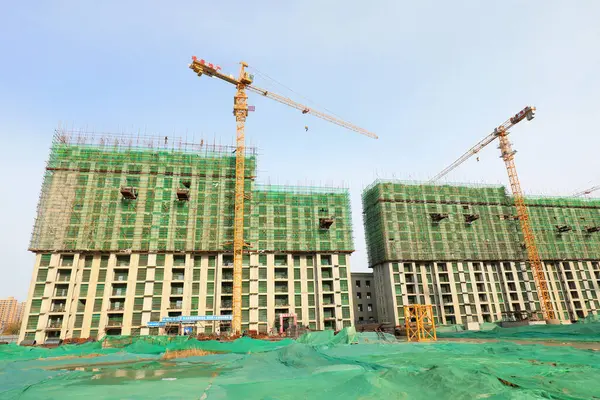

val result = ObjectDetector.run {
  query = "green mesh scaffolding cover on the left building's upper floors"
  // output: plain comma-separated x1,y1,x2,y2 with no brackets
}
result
30,135,354,252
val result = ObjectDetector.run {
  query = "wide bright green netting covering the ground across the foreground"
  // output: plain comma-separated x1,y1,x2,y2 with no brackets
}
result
0,324,600,400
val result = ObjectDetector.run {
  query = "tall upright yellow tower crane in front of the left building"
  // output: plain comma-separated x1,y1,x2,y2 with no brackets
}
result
189,56,377,334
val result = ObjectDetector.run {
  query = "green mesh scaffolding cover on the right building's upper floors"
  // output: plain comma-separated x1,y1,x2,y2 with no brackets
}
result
362,180,600,265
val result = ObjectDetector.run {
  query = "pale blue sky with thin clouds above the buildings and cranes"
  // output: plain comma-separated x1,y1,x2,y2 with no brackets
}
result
0,0,600,300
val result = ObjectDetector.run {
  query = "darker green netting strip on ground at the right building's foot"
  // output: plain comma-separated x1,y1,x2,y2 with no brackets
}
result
438,322,600,342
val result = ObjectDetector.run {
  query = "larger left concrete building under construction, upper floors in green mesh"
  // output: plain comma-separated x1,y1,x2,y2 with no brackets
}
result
20,131,354,343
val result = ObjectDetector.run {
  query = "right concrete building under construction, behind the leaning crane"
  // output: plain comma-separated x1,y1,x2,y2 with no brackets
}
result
362,180,600,324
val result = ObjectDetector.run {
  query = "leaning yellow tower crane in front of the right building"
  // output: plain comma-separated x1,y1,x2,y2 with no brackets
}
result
430,106,556,320
